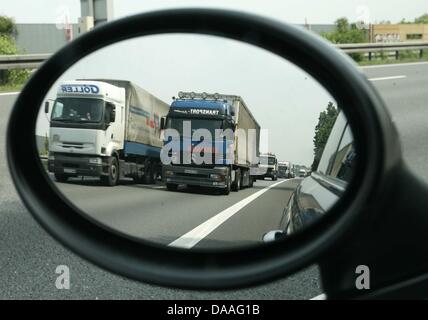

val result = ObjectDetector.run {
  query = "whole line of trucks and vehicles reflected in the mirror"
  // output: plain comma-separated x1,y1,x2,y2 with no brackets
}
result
44,79,304,194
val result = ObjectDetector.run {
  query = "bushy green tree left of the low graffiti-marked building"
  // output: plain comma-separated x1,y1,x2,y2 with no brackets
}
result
322,18,368,61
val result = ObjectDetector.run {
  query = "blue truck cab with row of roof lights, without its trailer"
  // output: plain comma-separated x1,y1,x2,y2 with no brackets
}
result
163,92,260,194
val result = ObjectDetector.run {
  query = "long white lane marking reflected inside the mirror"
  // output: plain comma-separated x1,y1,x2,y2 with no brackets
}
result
169,180,286,249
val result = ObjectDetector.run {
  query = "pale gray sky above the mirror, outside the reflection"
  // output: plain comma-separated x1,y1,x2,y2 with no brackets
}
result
0,0,428,23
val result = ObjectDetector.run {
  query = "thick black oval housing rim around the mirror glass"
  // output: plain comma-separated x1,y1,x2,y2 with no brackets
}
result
7,9,406,290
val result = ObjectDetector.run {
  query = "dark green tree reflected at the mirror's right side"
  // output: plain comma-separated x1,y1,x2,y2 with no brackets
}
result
312,102,339,171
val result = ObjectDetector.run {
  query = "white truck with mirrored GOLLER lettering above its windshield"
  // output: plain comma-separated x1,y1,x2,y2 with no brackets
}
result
44,79,169,186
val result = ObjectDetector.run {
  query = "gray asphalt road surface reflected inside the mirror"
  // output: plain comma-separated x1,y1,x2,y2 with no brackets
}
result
50,175,300,249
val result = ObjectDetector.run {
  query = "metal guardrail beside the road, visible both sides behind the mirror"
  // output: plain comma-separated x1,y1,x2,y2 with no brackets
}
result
0,41,428,70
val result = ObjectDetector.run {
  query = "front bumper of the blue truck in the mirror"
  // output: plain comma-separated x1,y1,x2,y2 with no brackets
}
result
162,165,229,188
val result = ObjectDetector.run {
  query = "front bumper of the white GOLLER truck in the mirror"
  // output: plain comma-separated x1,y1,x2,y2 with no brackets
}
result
48,154,108,177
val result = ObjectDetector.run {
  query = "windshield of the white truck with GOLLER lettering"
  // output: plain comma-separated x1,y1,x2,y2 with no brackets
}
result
51,98,104,122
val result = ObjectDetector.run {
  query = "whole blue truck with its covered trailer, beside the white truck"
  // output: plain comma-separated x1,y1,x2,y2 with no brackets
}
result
163,92,260,194
